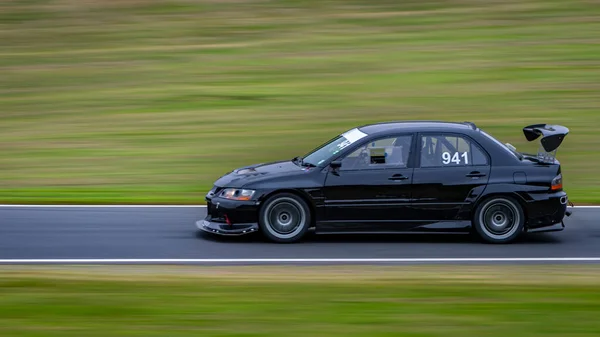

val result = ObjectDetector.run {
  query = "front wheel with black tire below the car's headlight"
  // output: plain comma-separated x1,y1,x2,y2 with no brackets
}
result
258,193,312,243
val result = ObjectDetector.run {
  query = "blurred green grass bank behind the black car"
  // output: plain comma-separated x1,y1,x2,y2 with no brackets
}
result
0,0,600,204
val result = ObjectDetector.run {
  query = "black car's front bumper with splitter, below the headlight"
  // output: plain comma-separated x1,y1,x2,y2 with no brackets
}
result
196,197,259,236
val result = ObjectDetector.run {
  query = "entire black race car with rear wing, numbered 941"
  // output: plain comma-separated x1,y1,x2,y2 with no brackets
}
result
196,121,570,243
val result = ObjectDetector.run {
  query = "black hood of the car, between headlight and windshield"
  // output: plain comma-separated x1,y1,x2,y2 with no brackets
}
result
215,160,306,188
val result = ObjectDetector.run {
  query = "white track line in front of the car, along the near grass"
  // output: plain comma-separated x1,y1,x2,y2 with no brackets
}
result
0,257,600,264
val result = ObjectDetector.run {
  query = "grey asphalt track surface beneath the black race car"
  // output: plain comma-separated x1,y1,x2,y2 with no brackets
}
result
0,205,600,265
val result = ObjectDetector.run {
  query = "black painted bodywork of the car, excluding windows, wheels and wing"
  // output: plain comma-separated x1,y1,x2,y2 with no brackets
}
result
198,122,567,235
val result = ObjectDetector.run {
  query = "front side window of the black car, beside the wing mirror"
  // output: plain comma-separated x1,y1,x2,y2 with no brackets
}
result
340,136,412,171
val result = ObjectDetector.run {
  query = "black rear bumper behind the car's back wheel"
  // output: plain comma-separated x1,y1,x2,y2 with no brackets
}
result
526,191,571,233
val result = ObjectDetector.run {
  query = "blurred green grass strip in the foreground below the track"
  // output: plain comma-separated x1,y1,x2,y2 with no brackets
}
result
0,266,600,337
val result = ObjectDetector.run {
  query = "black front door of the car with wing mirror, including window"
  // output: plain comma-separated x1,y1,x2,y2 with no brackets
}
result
319,134,414,231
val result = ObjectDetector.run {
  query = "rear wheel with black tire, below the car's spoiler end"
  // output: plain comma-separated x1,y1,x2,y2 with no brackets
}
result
473,196,525,243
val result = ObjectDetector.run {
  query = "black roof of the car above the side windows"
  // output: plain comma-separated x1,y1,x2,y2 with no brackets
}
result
358,120,478,134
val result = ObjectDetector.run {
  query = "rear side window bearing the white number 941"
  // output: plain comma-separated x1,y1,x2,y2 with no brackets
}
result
421,135,487,167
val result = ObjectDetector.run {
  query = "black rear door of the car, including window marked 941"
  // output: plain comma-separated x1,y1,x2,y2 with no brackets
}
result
412,133,490,221
